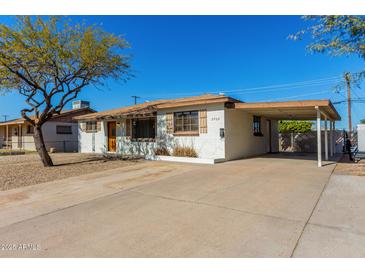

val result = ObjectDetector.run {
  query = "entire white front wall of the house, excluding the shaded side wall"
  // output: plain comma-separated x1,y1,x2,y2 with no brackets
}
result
79,104,225,159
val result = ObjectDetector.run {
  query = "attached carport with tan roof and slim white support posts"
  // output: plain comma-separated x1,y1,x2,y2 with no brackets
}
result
235,100,341,167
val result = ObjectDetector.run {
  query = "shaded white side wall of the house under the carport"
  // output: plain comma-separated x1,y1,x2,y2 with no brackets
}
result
225,109,278,160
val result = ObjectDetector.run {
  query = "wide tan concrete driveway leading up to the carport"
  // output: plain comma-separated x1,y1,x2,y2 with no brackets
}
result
0,155,335,257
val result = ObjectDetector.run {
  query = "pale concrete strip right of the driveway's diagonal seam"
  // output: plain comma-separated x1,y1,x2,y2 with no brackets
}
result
294,174,365,257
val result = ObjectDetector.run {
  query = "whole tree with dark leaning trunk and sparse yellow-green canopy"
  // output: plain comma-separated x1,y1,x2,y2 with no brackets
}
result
0,16,130,166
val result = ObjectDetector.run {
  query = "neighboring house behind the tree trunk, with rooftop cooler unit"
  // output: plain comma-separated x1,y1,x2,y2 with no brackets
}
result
0,101,95,152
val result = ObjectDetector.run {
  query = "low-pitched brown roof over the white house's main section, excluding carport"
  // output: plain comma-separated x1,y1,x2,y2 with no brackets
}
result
75,94,241,120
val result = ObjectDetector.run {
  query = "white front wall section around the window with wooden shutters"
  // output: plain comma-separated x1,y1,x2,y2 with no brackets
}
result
157,104,225,159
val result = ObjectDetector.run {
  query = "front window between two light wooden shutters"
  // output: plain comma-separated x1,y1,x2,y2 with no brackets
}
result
174,111,199,134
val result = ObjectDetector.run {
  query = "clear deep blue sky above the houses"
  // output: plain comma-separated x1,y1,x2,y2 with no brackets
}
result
0,16,365,128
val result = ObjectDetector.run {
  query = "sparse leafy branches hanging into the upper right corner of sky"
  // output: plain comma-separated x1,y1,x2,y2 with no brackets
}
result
289,15,365,86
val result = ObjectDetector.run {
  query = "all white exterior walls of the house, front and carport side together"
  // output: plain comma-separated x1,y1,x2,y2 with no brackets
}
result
79,104,279,160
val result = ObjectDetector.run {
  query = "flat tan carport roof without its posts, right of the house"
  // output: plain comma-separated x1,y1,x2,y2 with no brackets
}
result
234,100,341,121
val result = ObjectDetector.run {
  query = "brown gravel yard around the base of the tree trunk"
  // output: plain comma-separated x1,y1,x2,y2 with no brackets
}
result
0,153,143,190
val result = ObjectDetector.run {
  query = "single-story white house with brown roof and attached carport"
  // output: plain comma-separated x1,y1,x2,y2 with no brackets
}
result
75,94,340,166
